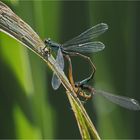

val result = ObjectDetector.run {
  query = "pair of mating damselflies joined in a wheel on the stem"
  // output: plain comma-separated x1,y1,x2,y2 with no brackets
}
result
45,23,140,110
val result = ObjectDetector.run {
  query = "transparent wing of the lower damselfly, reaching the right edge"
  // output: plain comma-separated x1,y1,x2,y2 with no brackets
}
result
96,90,140,110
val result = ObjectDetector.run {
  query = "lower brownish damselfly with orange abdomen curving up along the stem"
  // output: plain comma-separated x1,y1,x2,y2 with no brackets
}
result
67,56,140,111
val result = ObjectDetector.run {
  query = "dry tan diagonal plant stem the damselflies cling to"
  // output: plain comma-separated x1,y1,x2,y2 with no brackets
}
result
0,2,100,139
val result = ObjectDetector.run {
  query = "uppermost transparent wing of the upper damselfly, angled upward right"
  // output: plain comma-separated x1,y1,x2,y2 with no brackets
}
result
62,23,108,47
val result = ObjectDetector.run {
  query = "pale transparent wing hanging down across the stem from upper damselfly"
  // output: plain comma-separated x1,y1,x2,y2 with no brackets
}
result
52,48,64,90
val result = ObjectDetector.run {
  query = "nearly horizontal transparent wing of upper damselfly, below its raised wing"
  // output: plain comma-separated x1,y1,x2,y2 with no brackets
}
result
64,41,105,53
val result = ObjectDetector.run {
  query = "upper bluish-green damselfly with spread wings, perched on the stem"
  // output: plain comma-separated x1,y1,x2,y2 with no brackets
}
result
45,23,108,90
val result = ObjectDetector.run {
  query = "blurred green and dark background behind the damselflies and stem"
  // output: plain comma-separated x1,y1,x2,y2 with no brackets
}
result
0,0,140,139
